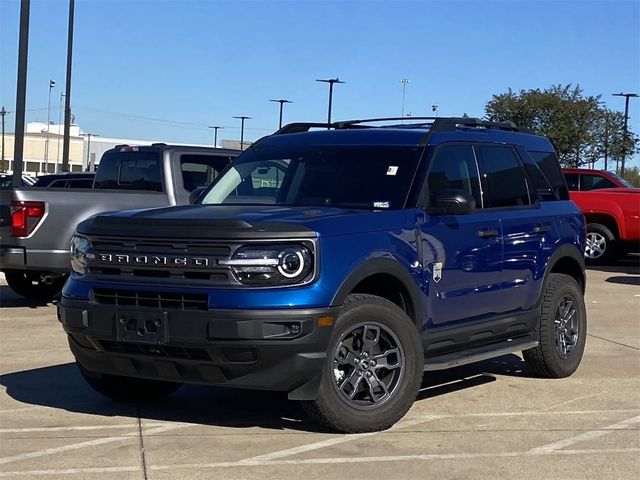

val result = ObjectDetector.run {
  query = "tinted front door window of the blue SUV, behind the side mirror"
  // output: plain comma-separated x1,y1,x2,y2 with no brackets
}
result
427,145,482,208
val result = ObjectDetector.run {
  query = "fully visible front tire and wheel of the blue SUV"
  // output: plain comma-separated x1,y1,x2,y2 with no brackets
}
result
302,294,424,433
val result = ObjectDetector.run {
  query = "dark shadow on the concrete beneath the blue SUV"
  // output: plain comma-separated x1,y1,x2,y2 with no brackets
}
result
0,355,526,433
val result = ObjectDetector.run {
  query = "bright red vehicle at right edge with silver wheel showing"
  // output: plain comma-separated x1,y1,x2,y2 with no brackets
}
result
571,187,640,265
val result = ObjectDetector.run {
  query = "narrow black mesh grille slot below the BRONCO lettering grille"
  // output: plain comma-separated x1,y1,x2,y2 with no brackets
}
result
93,288,209,310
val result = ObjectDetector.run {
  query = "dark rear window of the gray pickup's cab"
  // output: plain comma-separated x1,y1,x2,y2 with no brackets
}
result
94,151,163,192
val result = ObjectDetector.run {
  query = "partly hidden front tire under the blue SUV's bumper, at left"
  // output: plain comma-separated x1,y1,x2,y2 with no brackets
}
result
78,364,182,402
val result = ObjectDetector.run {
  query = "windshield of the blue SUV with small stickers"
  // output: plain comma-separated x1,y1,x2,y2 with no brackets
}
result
202,146,421,209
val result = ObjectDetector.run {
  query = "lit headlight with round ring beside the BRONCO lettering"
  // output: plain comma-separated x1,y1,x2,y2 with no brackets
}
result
219,244,313,287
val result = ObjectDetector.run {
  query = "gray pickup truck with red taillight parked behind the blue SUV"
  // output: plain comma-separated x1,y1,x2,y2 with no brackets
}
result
0,144,240,298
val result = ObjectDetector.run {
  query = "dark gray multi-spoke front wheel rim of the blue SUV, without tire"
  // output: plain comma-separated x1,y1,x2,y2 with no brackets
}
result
332,322,405,410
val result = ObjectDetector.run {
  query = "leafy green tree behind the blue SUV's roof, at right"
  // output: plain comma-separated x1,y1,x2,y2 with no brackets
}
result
485,84,639,167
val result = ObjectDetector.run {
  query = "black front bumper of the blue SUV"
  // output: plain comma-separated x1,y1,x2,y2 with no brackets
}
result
58,296,338,400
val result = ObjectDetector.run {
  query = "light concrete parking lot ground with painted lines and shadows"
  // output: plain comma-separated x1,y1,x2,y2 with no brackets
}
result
0,257,640,480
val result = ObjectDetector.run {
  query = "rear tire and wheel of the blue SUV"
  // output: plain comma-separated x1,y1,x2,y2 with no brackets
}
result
523,273,587,378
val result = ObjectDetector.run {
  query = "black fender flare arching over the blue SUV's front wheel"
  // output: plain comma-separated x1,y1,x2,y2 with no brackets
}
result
331,258,425,327
